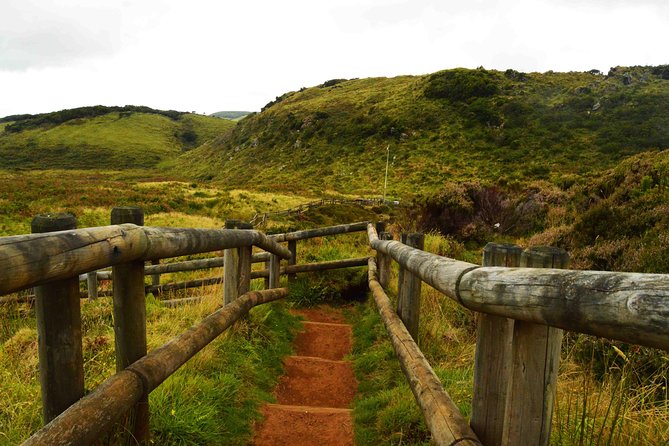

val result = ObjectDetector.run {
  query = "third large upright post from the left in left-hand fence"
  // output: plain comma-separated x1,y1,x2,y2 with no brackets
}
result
223,220,253,305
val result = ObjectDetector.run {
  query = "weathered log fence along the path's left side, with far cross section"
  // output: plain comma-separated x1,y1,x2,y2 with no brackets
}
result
0,207,367,445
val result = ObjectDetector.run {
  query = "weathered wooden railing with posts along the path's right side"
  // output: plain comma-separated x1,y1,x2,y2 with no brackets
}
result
368,225,669,446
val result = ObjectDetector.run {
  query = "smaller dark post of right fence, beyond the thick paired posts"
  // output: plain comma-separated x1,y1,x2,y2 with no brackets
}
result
397,232,425,343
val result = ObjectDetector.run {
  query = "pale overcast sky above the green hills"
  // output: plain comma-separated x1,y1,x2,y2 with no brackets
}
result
0,0,669,117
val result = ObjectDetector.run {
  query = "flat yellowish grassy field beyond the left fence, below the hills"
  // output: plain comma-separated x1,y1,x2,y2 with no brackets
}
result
0,169,320,236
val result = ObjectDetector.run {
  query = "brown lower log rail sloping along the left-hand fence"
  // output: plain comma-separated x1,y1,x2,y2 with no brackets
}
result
24,288,288,446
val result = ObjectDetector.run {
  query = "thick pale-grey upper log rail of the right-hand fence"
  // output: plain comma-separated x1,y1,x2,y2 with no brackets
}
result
368,224,669,351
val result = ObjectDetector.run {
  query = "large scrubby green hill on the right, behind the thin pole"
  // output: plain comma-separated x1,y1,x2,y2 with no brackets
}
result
178,66,669,195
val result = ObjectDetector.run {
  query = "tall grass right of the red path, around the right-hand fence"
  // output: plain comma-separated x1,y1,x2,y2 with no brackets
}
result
353,234,669,446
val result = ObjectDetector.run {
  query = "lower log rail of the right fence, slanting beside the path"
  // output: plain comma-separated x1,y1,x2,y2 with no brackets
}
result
368,258,481,446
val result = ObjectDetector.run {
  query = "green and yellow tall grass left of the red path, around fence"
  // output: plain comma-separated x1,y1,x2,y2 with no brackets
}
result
0,280,299,445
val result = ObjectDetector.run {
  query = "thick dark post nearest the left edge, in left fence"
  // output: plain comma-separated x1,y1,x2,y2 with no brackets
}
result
31,214,84,424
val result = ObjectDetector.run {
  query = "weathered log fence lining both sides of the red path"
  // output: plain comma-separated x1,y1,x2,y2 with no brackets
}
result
0,213,669,446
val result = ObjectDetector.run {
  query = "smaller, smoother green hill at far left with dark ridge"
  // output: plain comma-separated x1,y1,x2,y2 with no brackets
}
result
0,106,235,169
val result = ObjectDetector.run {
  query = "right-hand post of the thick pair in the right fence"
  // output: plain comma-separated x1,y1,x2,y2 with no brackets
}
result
502,247,569,446
